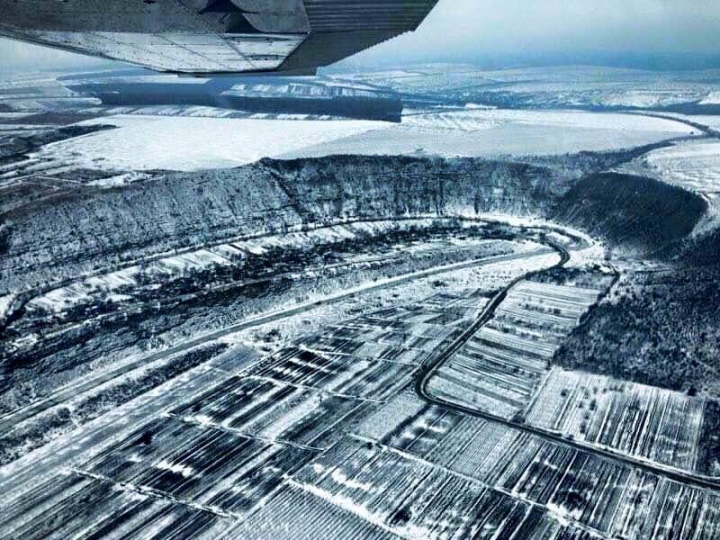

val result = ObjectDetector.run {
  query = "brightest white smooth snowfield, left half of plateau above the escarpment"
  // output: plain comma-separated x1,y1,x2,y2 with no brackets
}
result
32,116,383,171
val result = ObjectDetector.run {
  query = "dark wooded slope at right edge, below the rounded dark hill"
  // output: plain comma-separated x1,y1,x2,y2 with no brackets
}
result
555,230,720,398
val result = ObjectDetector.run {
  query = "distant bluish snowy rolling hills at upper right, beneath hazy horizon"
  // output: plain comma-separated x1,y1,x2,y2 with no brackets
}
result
343,64,718,109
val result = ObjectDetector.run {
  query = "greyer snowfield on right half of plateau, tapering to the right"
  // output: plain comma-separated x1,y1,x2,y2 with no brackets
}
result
282,109,694,157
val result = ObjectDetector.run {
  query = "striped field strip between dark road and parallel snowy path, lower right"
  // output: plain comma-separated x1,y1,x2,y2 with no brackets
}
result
352,393,720,539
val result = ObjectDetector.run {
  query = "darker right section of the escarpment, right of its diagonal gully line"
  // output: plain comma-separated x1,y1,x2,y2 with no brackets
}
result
261,156,568,222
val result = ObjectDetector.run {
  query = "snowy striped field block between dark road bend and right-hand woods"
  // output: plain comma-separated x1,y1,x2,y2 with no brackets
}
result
427,280,602,419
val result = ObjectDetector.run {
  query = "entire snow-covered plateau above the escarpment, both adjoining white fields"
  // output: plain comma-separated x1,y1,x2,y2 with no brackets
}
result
25,109,693,171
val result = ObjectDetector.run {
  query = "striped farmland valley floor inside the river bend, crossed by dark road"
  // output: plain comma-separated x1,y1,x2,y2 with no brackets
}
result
0,221,720,539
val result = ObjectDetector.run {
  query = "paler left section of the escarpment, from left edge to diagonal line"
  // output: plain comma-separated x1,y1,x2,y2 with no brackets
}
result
0,167,301,294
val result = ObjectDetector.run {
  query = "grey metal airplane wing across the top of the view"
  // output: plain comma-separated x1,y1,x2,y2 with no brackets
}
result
0,0,438,74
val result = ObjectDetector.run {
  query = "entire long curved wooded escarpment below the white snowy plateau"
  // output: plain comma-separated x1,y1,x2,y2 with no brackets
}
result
0,157,564,290
